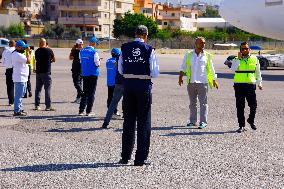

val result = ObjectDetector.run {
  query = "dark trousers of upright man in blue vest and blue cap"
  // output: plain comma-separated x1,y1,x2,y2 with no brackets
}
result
79,76,98,113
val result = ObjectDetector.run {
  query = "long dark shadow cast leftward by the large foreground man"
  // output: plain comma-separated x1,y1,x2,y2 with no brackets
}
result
1,163,130,172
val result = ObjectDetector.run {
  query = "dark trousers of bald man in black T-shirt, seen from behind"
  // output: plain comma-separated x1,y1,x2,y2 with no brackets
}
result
35,73,52,108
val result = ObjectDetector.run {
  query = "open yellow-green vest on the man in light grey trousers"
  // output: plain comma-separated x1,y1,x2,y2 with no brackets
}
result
186,51,213,89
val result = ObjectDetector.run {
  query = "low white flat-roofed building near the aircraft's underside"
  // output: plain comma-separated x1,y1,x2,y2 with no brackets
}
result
197,18,232,31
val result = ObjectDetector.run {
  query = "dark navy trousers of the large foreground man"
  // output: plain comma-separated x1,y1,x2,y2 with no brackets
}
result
121,89,152,162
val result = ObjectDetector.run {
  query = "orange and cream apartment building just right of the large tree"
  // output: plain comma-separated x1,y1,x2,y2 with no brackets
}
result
134,0,198,31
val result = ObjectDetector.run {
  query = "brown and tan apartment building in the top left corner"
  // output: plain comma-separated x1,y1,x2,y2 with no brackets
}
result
0,0,44,35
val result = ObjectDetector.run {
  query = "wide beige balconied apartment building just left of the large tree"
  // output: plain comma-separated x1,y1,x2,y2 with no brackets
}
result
58,0,134,38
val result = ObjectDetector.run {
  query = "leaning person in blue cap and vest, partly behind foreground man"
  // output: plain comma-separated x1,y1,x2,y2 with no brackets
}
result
102,48,124,129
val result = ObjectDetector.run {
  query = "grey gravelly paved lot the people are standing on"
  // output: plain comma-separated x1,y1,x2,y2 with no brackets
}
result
0,49,284,189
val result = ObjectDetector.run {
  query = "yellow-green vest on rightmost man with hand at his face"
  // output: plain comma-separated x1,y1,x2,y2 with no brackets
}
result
234,56,257,83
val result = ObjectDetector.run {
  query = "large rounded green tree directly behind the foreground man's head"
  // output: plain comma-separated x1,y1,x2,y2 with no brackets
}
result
113,12,158,38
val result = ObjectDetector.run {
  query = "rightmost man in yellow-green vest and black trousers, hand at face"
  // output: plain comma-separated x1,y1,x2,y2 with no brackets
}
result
231,42,262,133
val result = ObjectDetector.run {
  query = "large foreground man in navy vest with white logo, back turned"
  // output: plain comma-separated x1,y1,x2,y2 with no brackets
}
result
118,25,159,166
